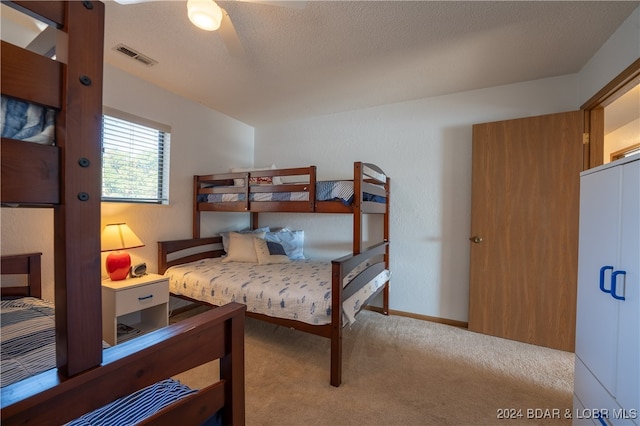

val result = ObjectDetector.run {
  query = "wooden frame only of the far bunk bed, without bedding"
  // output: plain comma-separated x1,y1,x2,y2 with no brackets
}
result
158,162,391,386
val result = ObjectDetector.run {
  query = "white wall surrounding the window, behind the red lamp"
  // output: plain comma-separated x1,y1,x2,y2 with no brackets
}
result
1,65,254,300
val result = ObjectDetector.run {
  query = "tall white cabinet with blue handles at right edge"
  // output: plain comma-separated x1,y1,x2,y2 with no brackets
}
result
574,156,640,425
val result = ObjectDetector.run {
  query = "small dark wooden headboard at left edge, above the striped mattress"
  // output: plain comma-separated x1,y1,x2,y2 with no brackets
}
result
0,253,42,298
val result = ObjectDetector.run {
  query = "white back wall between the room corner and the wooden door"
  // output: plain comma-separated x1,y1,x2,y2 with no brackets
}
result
255,75,577,321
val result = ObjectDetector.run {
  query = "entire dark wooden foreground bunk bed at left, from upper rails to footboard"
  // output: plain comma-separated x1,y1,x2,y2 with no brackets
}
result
0,1,246,425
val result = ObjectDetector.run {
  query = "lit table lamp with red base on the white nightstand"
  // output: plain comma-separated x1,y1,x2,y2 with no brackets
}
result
101,223,144,281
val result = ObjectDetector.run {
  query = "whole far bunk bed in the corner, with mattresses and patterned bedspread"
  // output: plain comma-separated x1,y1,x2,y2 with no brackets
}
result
158,162,390,386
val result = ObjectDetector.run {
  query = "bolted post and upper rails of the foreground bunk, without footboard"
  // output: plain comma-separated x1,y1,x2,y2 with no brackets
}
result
0,1,104,376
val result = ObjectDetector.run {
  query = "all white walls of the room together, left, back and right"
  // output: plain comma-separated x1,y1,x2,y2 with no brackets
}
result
0,5,640,321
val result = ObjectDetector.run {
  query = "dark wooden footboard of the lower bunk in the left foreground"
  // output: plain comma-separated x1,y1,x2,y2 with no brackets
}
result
1,303,246,425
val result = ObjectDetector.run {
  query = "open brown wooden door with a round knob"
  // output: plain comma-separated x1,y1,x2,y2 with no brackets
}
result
469,111,582,351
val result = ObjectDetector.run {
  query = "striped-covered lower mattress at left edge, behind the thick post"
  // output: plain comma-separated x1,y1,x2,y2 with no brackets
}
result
0,297,56,387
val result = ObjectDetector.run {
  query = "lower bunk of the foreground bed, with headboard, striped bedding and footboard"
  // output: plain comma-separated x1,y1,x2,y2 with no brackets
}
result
0,253,246,424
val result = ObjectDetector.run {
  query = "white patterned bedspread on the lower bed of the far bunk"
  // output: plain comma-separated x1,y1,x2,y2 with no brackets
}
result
165,258,389,325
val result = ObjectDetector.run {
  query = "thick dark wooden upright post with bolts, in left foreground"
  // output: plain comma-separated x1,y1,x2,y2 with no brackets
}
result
53,1,104,376
